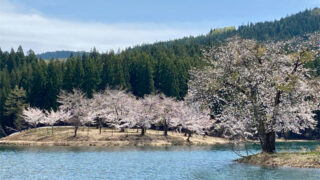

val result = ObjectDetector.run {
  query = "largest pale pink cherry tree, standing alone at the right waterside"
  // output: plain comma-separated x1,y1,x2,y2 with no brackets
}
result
189,33,320,153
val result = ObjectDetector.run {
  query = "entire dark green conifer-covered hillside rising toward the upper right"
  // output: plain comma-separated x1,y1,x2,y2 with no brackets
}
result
0,9,320,135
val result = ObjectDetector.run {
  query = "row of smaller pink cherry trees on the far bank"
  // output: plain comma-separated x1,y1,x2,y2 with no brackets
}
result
22,89,213,141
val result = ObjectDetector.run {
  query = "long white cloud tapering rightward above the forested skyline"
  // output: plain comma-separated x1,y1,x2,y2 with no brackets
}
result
0,1,209,53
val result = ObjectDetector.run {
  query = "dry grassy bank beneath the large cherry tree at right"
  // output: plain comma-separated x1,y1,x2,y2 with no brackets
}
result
237,149,320,168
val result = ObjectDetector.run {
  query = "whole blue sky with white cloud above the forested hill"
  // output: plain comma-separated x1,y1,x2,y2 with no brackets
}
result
0,0,320,53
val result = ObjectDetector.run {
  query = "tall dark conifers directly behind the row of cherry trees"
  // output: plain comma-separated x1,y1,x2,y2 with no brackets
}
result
0,45,200,134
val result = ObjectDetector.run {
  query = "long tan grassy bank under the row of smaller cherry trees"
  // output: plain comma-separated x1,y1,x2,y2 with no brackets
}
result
0,127,228,147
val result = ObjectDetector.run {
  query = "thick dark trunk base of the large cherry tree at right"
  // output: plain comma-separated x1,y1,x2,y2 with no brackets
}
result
259,132,276,153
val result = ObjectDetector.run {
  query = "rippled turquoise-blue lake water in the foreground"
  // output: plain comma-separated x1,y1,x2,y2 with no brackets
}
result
0,142,320,180
